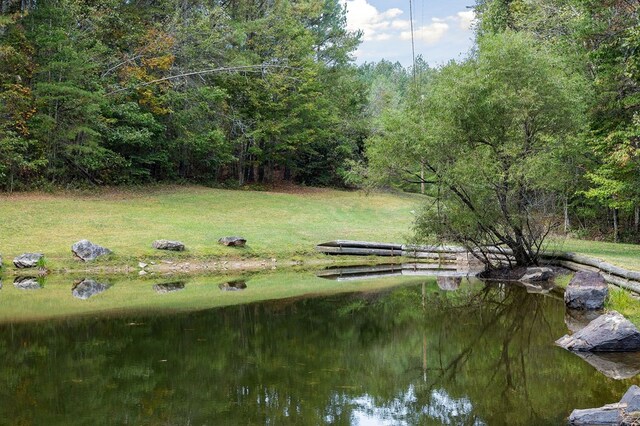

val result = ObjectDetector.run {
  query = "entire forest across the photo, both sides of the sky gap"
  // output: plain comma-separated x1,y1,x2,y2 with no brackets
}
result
0,0,640,246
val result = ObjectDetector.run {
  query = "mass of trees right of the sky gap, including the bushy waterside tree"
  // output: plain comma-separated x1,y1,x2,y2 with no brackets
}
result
367,0,640,253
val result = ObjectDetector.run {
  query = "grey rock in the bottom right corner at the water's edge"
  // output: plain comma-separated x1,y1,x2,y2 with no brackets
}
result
569,385,640,426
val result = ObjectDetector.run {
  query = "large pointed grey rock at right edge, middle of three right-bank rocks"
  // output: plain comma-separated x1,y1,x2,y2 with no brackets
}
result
556,311,640,352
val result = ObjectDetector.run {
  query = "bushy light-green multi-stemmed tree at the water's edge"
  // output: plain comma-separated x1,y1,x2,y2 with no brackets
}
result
372,31,584,265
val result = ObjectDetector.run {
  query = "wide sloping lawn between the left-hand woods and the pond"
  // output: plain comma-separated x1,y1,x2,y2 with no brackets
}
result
0,186,420,270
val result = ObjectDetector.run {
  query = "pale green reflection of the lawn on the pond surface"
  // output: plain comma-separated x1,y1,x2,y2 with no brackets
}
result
0,270,432,323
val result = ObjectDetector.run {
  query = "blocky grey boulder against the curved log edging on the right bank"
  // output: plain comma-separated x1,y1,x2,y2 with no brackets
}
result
564,271,609,309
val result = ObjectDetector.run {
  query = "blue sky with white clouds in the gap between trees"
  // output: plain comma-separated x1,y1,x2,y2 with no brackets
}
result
345,0,475,66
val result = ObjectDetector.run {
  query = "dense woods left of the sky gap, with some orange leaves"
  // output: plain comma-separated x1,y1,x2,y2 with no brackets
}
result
0,0,366,191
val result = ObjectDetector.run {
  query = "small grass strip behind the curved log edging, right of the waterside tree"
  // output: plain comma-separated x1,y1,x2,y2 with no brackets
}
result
549,238,640,270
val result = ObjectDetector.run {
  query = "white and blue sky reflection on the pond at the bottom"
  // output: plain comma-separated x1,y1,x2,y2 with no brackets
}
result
342,386,485,426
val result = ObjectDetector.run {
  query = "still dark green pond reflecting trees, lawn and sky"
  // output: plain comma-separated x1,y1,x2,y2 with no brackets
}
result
0,271,640,425
